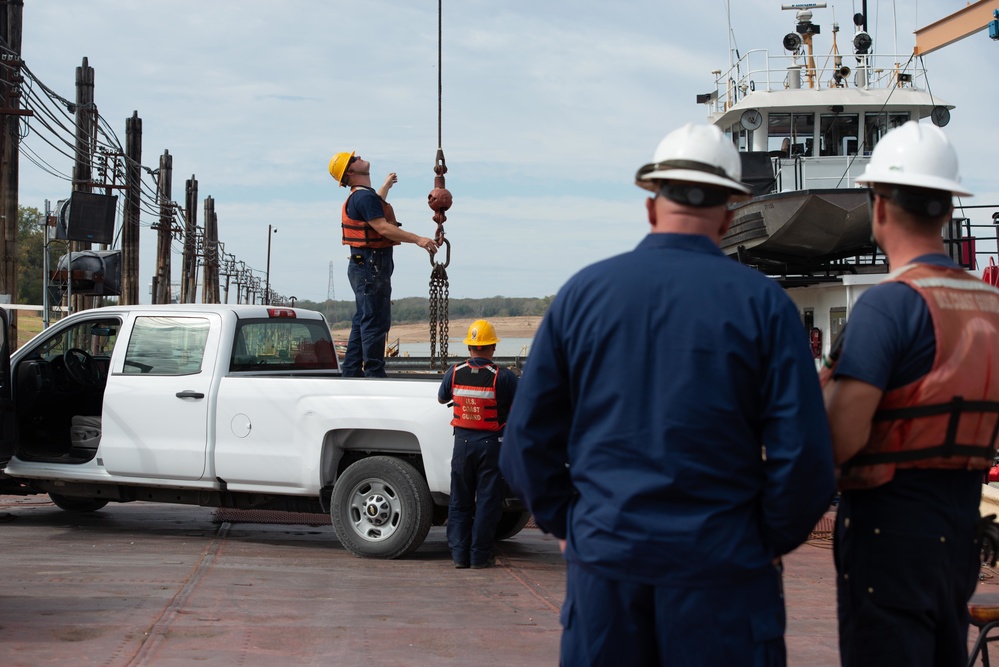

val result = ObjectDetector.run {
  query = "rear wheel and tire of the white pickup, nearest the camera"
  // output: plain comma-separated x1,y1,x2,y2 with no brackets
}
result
330,456,434,558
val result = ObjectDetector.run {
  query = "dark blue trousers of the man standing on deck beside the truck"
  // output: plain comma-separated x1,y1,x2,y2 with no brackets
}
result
447,432,503,565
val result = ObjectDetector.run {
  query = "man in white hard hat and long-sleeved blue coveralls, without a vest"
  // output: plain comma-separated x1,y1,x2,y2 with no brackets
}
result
500,125,834,665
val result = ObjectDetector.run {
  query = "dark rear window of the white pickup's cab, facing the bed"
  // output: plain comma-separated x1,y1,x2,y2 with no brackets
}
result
229,319,337,372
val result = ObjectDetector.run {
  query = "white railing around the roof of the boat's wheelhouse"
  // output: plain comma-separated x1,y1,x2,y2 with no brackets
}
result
711,49,927,113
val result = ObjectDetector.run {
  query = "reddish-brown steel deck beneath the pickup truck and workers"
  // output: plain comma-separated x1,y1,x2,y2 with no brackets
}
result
0,496,999,667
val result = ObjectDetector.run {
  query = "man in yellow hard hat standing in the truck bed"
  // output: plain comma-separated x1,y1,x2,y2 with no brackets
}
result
329,152,437,377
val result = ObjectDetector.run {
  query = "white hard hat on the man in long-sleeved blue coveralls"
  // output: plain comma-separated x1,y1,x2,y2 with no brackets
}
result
635,123,752,195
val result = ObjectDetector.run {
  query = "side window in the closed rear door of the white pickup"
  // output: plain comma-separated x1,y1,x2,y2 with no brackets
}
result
123,317,210,375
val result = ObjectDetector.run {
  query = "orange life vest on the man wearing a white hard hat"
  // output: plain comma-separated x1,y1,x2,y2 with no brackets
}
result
839,264,999,490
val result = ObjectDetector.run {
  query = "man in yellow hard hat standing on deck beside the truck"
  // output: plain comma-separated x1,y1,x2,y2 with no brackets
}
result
437,320,517,569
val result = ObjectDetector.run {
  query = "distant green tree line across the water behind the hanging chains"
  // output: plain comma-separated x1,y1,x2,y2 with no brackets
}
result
295,296,554,329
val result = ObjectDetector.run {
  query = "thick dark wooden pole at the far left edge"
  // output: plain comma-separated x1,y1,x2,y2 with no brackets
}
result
0,0,25,352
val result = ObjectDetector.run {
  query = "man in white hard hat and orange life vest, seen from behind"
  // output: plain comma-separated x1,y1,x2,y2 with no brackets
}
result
822,121,999,666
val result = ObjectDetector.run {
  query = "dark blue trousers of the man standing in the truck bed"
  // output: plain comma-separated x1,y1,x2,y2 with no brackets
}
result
343,248,395,377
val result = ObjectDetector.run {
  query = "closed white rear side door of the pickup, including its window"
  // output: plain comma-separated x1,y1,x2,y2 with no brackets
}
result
100,313,222,480
